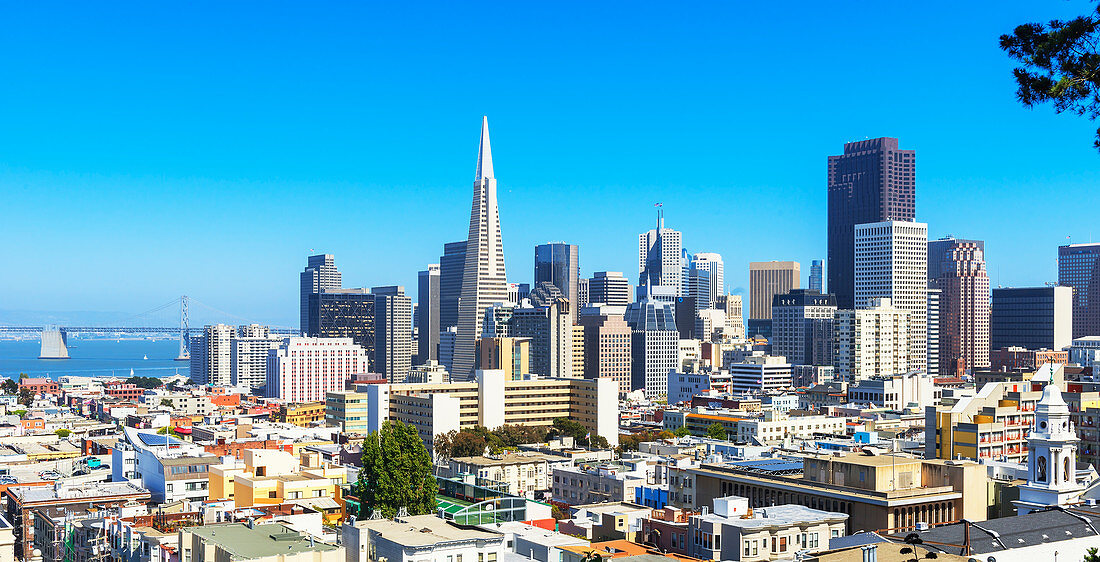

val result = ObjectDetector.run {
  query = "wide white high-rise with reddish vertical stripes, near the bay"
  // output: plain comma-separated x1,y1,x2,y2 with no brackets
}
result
265,338,370,403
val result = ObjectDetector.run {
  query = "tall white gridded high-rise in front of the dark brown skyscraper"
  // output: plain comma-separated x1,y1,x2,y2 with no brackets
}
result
855,221,928,371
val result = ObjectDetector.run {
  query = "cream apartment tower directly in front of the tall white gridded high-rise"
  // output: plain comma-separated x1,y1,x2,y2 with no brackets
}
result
834,298,924,383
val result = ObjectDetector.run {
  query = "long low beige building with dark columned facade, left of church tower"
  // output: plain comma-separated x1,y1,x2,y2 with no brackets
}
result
669,454,992,532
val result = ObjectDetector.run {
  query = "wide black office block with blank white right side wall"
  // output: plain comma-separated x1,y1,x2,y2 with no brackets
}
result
989,285,1075,350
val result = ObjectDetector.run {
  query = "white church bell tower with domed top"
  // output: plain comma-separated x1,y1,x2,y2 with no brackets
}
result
1013,384,1085,515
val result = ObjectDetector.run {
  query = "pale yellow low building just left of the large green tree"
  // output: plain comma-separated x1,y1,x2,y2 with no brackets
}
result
209,449,348,525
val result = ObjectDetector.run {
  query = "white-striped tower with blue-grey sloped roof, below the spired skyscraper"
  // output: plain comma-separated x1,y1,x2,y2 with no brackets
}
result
624,297,680,399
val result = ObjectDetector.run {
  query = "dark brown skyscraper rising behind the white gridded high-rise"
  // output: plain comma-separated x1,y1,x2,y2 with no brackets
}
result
827,137,916,309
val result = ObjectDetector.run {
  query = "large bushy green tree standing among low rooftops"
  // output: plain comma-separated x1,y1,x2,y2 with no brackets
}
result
353,420,438,518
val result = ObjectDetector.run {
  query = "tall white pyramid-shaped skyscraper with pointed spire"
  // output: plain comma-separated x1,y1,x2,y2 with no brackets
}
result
451,118,508,381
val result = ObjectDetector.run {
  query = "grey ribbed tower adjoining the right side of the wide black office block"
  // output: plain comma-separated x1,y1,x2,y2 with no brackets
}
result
371,286,413,383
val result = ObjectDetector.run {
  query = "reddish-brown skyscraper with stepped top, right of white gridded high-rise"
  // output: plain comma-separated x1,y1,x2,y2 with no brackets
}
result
928,236,989,373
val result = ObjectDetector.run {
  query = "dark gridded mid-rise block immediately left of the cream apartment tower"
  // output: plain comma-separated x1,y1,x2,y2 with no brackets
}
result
770,289,836,365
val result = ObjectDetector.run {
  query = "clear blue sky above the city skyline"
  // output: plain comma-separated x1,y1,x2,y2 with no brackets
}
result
0,1,1100,326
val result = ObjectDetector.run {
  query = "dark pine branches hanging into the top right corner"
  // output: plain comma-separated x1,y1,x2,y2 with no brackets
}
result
1001,7,1100,150
